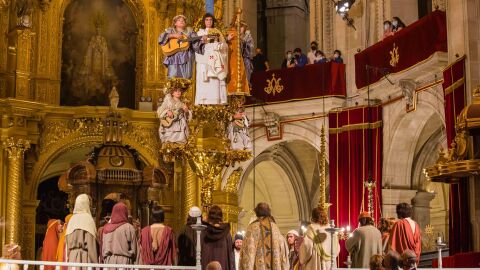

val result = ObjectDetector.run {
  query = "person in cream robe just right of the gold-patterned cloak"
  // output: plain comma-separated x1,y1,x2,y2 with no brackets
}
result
299,208,340,270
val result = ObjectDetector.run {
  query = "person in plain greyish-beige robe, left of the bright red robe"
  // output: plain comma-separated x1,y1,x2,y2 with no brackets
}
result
345,212,383,268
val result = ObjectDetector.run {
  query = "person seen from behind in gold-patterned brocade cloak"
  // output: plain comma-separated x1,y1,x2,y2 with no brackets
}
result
239,203,290,270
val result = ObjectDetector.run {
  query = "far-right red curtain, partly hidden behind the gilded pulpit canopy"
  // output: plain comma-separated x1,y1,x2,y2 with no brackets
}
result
443,57,472,254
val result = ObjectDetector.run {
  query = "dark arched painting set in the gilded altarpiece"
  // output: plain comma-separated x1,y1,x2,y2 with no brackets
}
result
60,0,137,108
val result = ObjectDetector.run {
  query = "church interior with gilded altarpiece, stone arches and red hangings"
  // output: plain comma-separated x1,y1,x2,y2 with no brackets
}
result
0,0,480,267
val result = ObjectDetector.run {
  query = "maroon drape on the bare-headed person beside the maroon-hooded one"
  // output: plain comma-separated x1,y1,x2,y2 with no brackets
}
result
140,226,177,265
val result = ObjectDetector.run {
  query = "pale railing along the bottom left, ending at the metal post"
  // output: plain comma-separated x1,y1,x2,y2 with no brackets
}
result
0,259,202,270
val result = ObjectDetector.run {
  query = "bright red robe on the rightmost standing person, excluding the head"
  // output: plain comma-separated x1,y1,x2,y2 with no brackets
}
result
388,219,422,262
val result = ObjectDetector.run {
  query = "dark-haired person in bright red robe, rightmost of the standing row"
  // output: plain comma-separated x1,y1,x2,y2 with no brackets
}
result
388,203,422,263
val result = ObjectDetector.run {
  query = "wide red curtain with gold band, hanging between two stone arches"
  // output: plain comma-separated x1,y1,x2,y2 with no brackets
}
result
329,106,382,267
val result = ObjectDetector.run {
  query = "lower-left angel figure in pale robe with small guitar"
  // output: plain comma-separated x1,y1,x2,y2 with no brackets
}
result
157,78,191,143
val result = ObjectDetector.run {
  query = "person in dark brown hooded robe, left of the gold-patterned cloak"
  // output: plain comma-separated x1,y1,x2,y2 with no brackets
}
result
201,205,235,270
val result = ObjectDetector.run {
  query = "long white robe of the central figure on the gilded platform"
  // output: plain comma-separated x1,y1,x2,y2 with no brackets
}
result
195,29,228,105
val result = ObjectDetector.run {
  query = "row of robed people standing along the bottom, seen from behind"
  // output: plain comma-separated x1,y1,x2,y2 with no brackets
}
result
30,194,421,270
